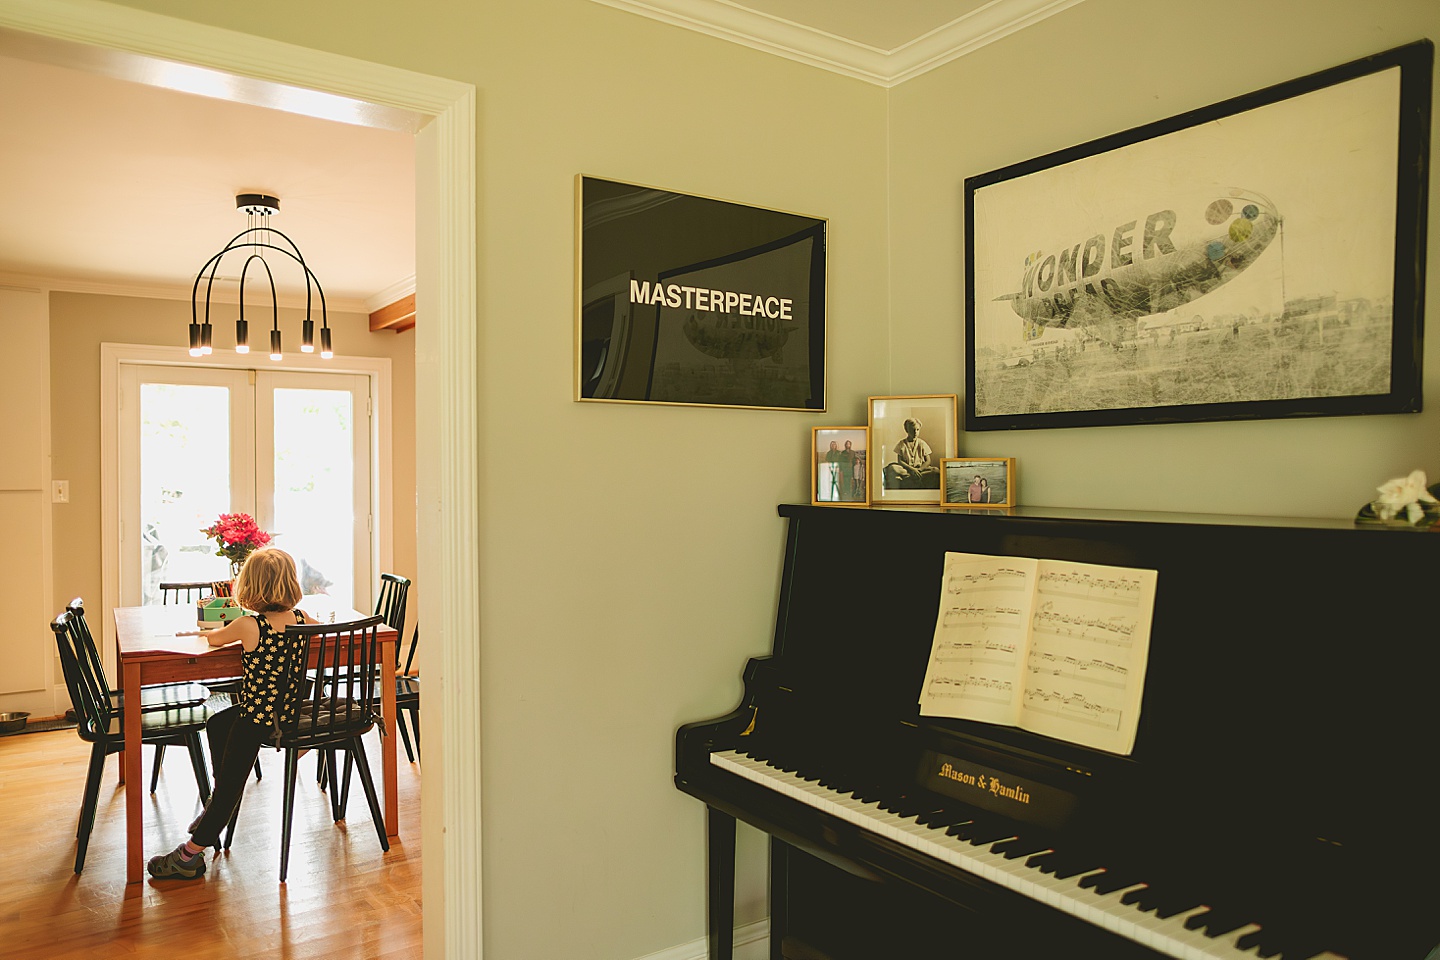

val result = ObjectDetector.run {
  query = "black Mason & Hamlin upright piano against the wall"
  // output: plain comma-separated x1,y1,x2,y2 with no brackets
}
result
675,505,1440,960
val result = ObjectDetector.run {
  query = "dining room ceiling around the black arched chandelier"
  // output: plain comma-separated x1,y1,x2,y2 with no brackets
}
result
0,48,415,312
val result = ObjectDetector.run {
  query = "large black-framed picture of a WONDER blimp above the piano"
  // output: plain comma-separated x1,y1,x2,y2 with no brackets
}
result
965,40,1434,430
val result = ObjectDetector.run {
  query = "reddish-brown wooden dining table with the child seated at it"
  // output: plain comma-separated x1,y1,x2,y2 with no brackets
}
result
115,596,400,884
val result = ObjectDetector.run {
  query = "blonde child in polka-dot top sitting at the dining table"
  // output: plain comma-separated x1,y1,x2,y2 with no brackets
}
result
147,547,320,879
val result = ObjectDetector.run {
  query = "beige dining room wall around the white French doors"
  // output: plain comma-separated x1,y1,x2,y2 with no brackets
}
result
50,294,419,610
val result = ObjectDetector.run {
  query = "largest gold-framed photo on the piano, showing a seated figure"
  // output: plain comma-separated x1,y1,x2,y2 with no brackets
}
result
870,393,959,504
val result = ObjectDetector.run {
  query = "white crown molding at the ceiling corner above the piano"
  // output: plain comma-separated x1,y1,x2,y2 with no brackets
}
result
593,0,1081,86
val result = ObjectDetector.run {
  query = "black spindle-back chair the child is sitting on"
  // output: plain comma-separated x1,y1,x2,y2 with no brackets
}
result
225,615,390,882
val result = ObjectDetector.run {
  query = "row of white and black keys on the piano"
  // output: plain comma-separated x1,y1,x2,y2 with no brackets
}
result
710,750,1344,960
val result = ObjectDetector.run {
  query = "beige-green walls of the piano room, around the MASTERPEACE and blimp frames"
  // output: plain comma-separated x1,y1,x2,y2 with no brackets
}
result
42,0,1440,960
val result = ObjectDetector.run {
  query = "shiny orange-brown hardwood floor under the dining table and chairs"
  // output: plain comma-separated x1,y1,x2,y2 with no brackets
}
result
0,730,420,960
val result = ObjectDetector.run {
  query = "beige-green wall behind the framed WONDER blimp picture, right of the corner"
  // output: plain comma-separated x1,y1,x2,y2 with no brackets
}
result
890,0,1440,518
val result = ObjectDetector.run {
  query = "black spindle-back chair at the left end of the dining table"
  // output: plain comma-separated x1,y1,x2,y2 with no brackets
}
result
50,604,210,874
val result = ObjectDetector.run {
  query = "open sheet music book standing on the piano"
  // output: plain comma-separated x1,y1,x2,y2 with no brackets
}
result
920,553,1159,756
